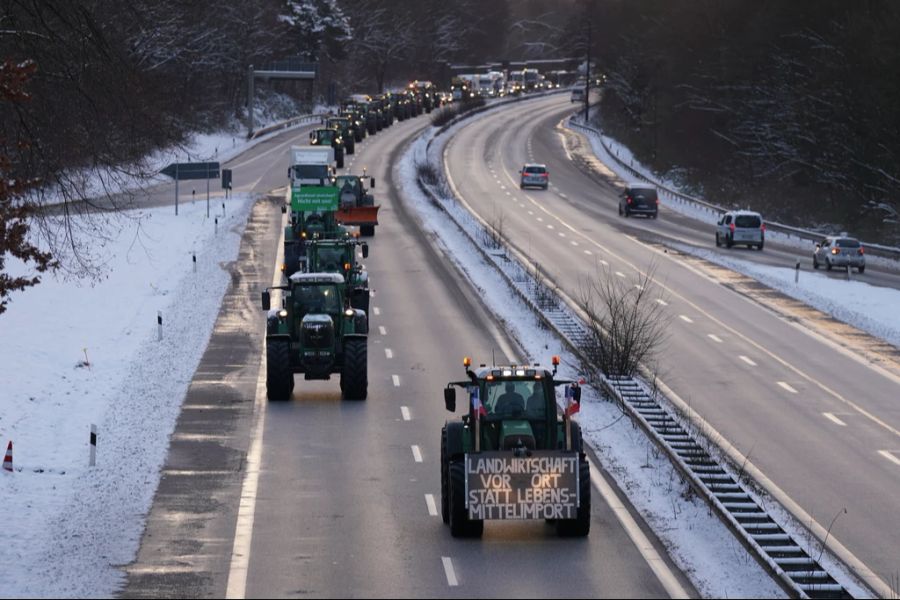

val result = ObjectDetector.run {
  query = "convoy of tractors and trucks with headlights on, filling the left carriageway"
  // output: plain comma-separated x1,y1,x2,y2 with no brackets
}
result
262,81,591,537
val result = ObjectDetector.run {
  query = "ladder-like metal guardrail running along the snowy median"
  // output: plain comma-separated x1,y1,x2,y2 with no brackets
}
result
419,176,853,598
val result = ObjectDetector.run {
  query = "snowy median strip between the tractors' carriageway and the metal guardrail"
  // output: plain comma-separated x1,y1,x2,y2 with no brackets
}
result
397,105,784,598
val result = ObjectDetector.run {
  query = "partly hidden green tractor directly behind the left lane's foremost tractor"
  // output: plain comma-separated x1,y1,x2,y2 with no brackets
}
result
306,238,369,318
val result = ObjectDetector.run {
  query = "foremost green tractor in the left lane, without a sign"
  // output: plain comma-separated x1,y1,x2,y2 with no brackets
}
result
262,273,369,400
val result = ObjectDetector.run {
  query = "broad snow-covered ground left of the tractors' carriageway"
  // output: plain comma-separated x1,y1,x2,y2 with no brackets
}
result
0,194,253,597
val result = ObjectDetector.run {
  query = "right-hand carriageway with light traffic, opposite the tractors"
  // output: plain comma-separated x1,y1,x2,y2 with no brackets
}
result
445,97,900,592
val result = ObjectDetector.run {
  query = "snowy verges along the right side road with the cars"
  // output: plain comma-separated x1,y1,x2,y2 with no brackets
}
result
578,122,900,348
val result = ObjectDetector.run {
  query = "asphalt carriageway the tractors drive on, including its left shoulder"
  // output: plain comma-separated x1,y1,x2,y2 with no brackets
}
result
122,105,696,598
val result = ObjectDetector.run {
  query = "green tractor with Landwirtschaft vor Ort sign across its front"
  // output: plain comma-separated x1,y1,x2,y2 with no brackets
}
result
441,356,591,537
